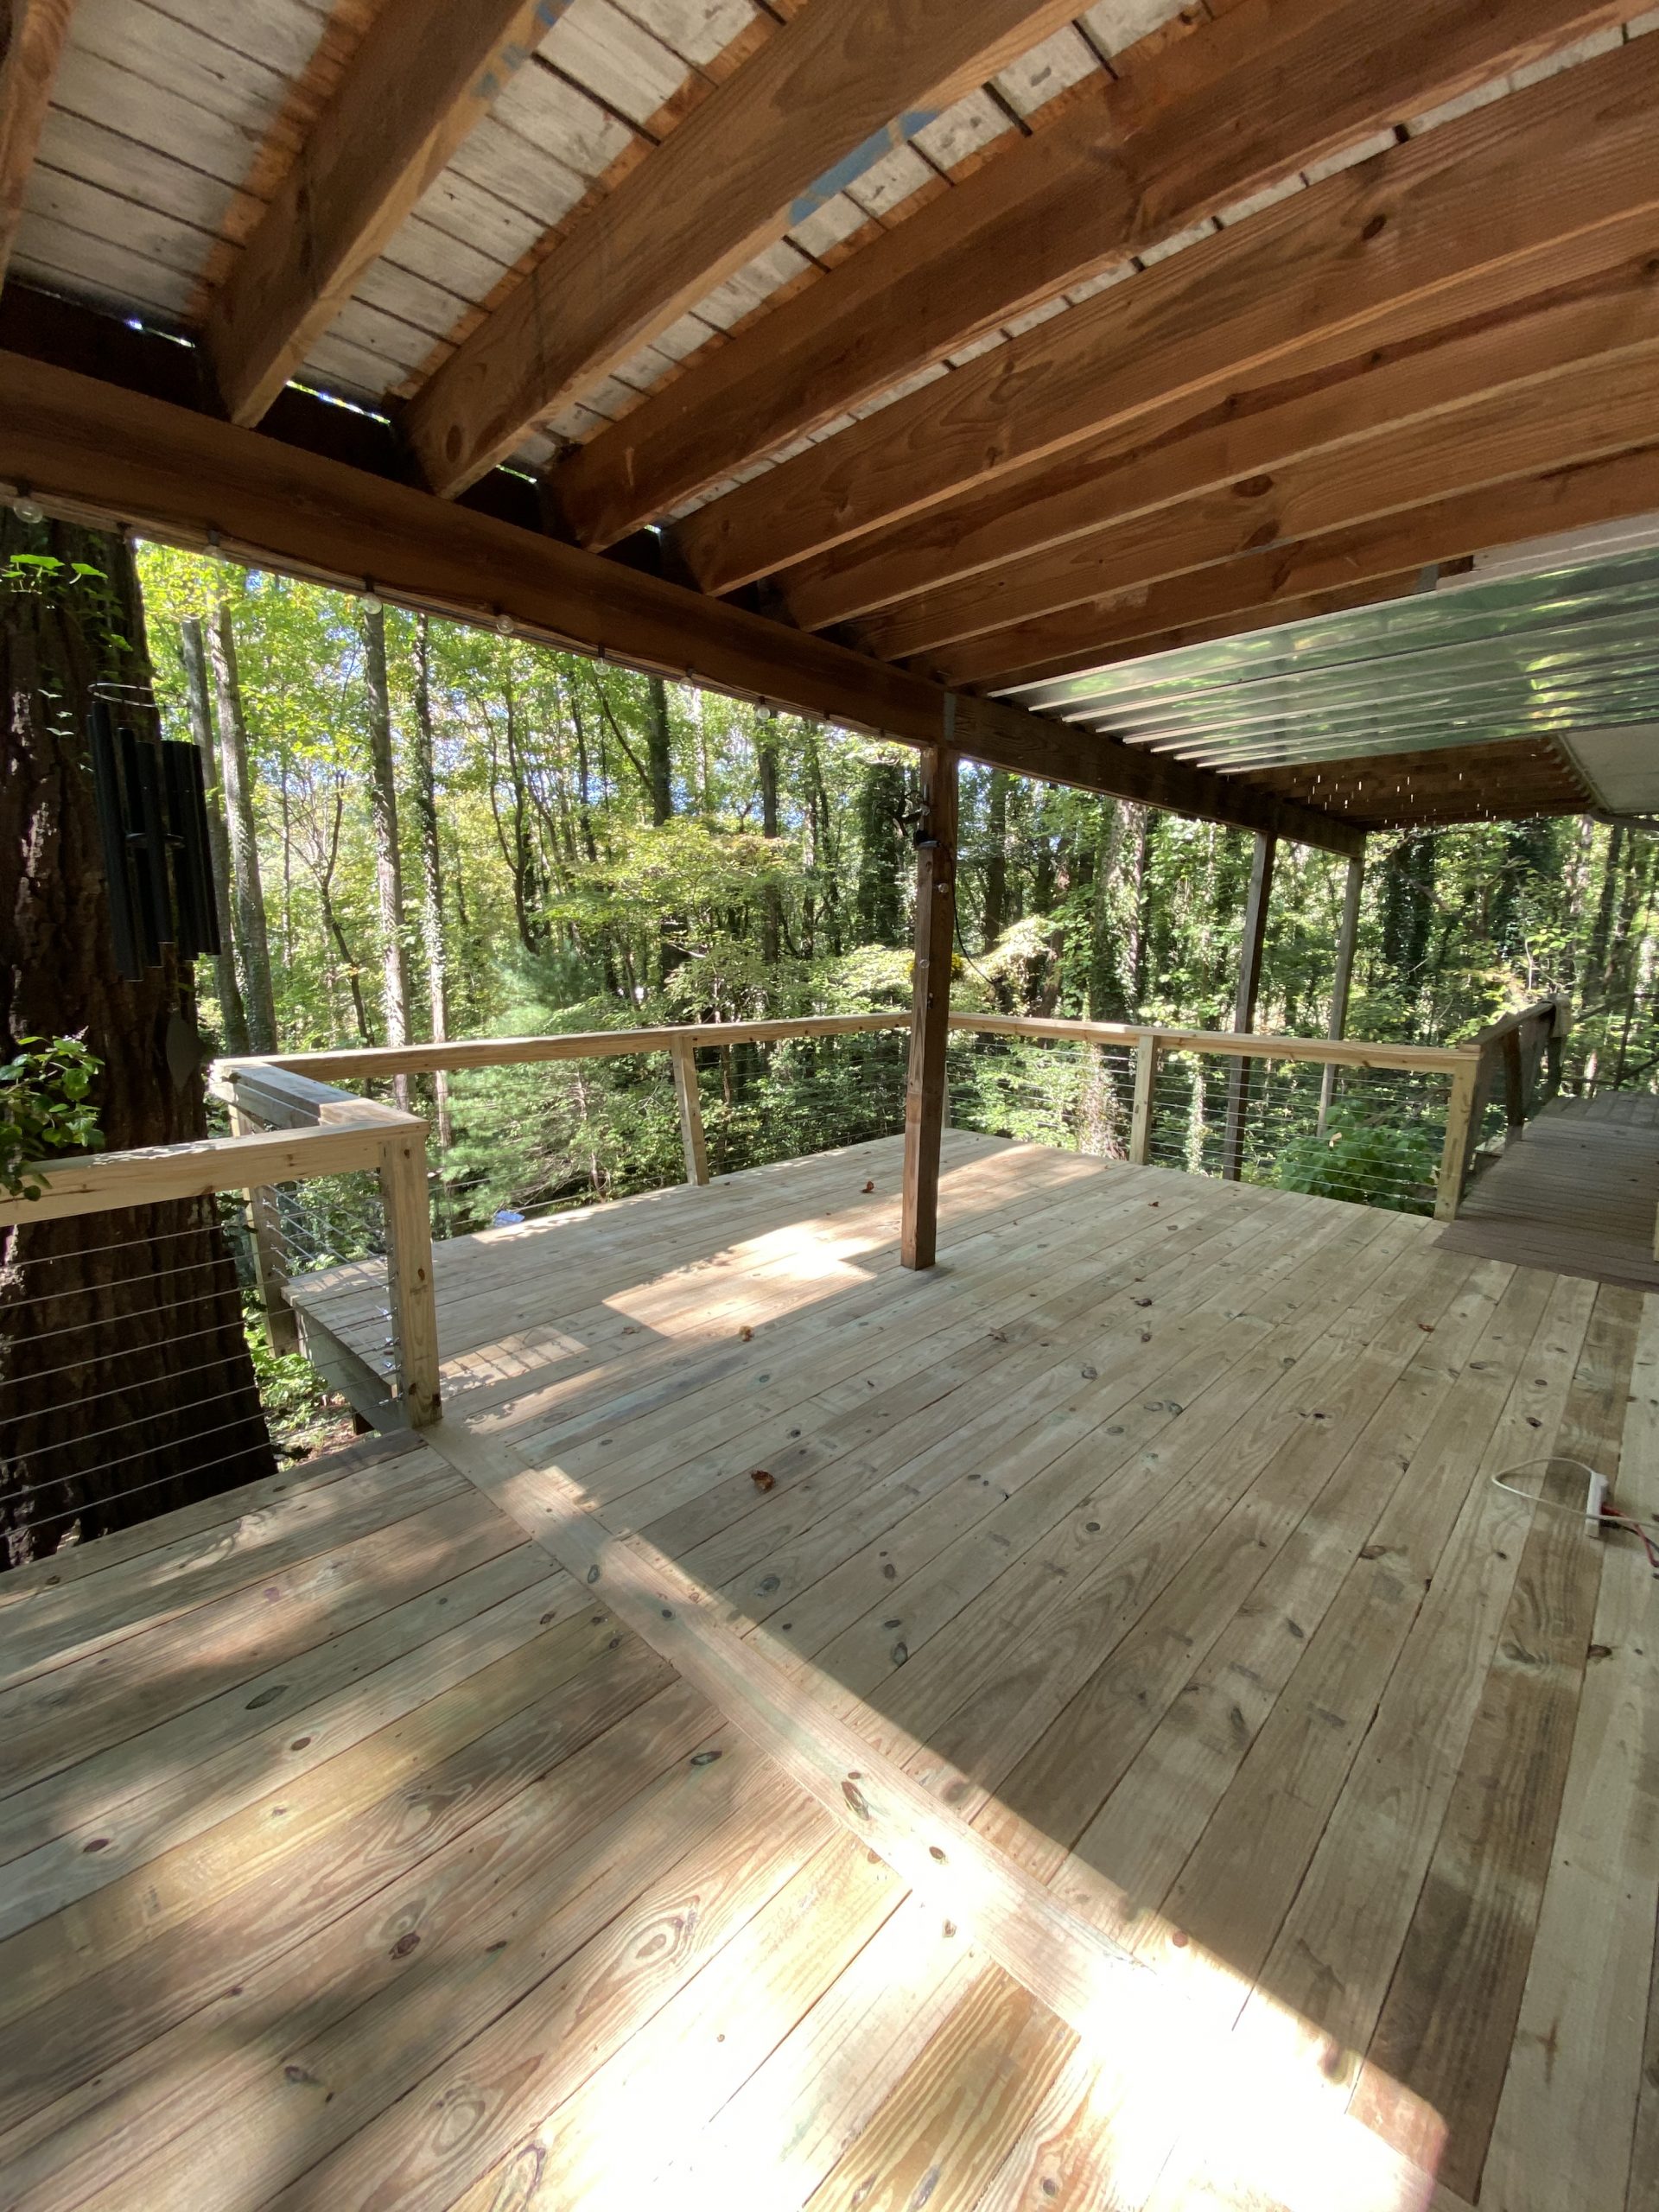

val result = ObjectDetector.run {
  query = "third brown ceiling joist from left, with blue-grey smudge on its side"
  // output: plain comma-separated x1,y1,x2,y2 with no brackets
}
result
407,0,1096,495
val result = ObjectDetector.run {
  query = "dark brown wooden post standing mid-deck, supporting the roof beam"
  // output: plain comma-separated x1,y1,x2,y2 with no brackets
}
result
898,746,956,1268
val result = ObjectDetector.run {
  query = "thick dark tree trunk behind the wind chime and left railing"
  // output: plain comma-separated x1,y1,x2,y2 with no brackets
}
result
0,509,274,1566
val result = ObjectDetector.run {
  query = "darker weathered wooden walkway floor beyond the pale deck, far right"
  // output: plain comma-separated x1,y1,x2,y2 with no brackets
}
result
1440,1090,1659,1289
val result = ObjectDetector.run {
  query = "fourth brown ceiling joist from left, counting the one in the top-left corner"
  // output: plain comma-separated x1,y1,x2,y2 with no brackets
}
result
557,0,1624,546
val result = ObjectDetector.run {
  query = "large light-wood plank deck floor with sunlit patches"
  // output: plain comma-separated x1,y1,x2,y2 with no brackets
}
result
0,1133,1659,2212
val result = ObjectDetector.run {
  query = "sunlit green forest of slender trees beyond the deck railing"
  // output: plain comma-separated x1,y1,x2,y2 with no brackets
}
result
139,546,1659,1228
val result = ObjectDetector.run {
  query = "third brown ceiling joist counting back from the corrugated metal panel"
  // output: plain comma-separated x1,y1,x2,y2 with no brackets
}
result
781,247,1659,651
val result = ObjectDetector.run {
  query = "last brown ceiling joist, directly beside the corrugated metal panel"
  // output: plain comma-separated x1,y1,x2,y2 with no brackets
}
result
942,445,1659,690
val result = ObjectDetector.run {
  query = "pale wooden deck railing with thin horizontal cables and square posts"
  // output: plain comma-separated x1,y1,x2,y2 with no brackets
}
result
0,1000,1566,1486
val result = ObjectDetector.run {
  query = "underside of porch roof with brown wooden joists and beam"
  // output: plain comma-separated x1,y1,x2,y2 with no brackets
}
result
0,0,1659,854
